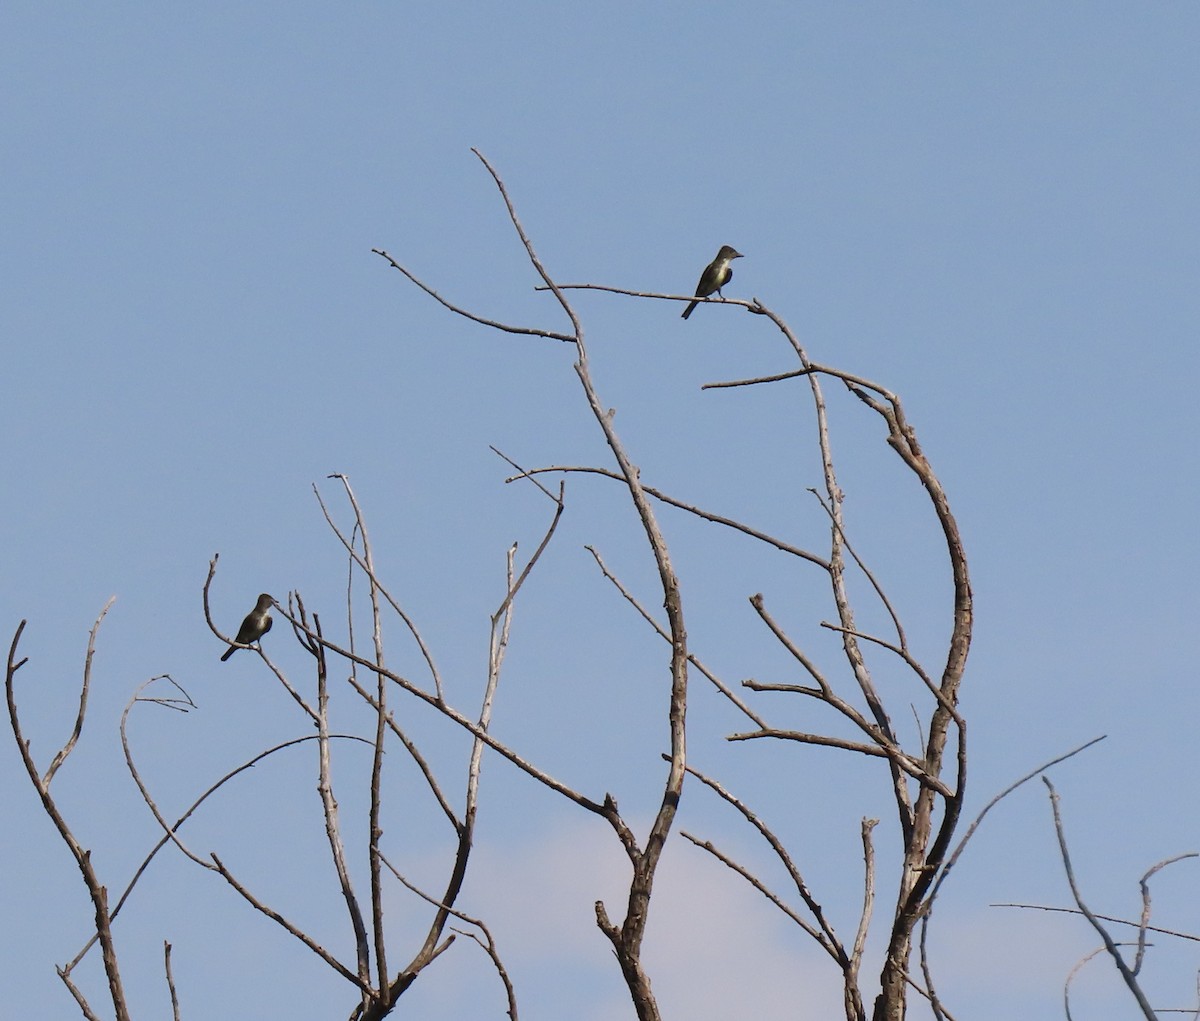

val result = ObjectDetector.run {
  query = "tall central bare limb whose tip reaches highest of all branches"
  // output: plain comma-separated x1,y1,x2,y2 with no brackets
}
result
472,149,688,1021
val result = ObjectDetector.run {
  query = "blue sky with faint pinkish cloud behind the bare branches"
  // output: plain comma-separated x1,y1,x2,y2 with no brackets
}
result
0,7,1200,1021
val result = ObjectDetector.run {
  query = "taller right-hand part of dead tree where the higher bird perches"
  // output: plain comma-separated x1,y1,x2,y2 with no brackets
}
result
377,152,972,1021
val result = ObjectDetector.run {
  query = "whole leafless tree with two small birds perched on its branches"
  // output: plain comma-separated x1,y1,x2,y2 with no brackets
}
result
18,154,1128,1021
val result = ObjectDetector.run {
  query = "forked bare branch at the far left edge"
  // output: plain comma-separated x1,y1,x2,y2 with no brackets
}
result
5,600,130,1021
